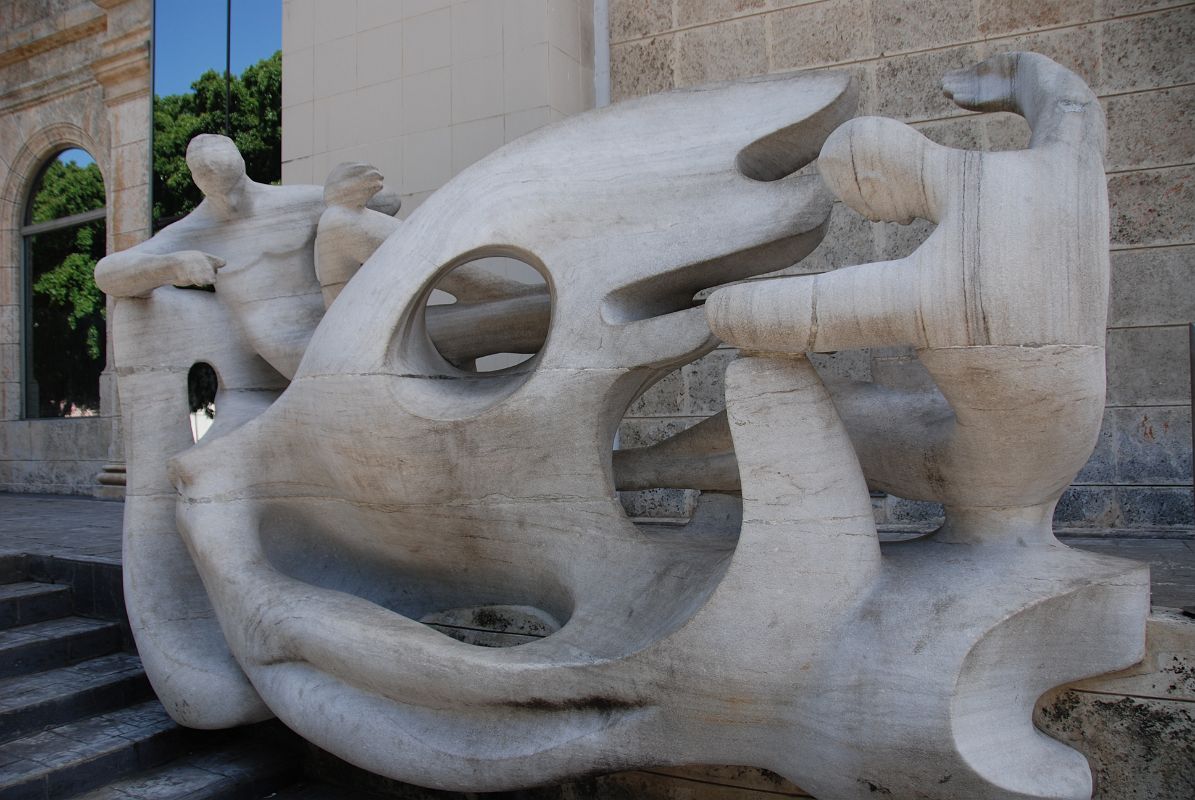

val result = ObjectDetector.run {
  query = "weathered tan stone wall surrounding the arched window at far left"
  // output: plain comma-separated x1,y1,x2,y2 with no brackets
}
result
0,0,152,494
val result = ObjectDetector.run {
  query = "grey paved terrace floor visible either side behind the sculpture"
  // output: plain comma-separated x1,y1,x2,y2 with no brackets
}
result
0,493,1195,609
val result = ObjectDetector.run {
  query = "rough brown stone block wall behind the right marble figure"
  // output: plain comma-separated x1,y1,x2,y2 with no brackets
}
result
609,0,1195,529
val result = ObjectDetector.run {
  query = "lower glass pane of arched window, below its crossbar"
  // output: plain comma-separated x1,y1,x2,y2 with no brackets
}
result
25,220,105,417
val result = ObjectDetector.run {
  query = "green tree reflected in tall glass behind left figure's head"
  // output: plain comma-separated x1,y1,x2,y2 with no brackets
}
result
153,51,282,226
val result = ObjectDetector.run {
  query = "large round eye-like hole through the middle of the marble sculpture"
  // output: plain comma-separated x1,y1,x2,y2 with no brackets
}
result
425,256,552,373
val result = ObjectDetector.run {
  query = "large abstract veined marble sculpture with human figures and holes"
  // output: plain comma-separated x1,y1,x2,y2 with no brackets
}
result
98,54,1148,800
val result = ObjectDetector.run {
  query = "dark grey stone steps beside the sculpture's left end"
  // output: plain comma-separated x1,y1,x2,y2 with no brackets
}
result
0,556,303,800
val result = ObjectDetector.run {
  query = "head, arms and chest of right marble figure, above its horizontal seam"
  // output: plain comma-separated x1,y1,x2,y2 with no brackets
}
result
706,53,1107,352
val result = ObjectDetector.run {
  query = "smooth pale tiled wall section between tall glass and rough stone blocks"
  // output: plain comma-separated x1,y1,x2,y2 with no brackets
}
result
282,0,593,214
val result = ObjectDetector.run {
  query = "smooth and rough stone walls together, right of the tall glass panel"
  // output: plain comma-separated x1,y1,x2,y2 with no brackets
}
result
282,0,1195,529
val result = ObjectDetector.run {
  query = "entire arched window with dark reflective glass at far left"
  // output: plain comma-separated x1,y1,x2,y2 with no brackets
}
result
20,148,106,419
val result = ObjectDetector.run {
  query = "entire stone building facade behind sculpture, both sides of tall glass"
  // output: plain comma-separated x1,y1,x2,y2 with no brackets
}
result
0,0,1195,529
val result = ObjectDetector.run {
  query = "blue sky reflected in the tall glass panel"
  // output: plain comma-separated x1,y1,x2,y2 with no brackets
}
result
154,0,282,94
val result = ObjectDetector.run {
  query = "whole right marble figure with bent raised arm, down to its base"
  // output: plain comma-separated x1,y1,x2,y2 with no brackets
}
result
706,54,1109,552
